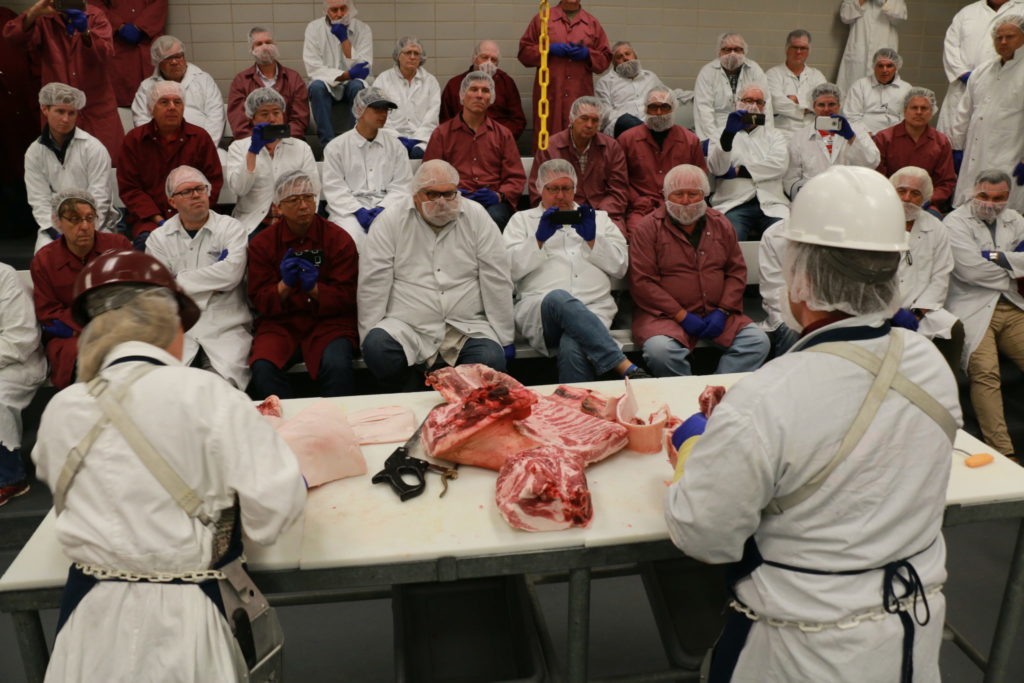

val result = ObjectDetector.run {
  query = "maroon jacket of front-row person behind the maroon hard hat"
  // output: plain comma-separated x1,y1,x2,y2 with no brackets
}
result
29,232,131,389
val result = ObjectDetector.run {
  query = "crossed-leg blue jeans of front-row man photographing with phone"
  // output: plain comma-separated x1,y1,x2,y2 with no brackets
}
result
541,290,626,382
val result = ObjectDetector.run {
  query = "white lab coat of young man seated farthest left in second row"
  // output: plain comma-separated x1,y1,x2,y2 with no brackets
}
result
25,128,118,251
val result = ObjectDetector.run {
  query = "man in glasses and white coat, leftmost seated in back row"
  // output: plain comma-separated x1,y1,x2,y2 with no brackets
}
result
131,36,224,146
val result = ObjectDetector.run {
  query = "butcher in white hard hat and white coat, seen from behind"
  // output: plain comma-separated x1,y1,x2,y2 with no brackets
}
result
666,167,962,683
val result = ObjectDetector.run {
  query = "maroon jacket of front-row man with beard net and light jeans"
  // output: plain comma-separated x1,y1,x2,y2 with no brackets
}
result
630,207,752,350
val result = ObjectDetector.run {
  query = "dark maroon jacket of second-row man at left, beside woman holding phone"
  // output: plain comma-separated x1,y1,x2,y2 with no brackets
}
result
117,121,224,237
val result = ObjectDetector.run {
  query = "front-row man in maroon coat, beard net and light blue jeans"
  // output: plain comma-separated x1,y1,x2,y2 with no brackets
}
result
630,164,769,377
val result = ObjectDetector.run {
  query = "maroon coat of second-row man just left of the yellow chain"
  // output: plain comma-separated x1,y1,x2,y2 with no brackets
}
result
423,115,526,200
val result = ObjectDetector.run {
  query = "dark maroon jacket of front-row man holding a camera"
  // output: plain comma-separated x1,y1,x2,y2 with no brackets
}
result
249,216,359,379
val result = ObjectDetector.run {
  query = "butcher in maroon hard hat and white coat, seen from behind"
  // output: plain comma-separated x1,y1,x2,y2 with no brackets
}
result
32,251,305,683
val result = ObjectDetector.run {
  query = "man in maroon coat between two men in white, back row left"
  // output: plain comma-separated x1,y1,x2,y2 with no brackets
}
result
227,26,309,140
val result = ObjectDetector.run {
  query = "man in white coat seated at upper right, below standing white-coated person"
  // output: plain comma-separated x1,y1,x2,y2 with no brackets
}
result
845,47,910,135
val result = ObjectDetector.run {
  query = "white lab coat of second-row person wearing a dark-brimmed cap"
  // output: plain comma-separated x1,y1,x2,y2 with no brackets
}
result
324,128,413,249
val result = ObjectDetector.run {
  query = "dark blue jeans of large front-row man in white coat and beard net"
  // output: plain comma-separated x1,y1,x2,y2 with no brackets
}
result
362,328,505,392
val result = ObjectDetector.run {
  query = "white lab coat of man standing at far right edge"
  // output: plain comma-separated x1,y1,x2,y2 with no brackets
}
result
949,49,1024,211
